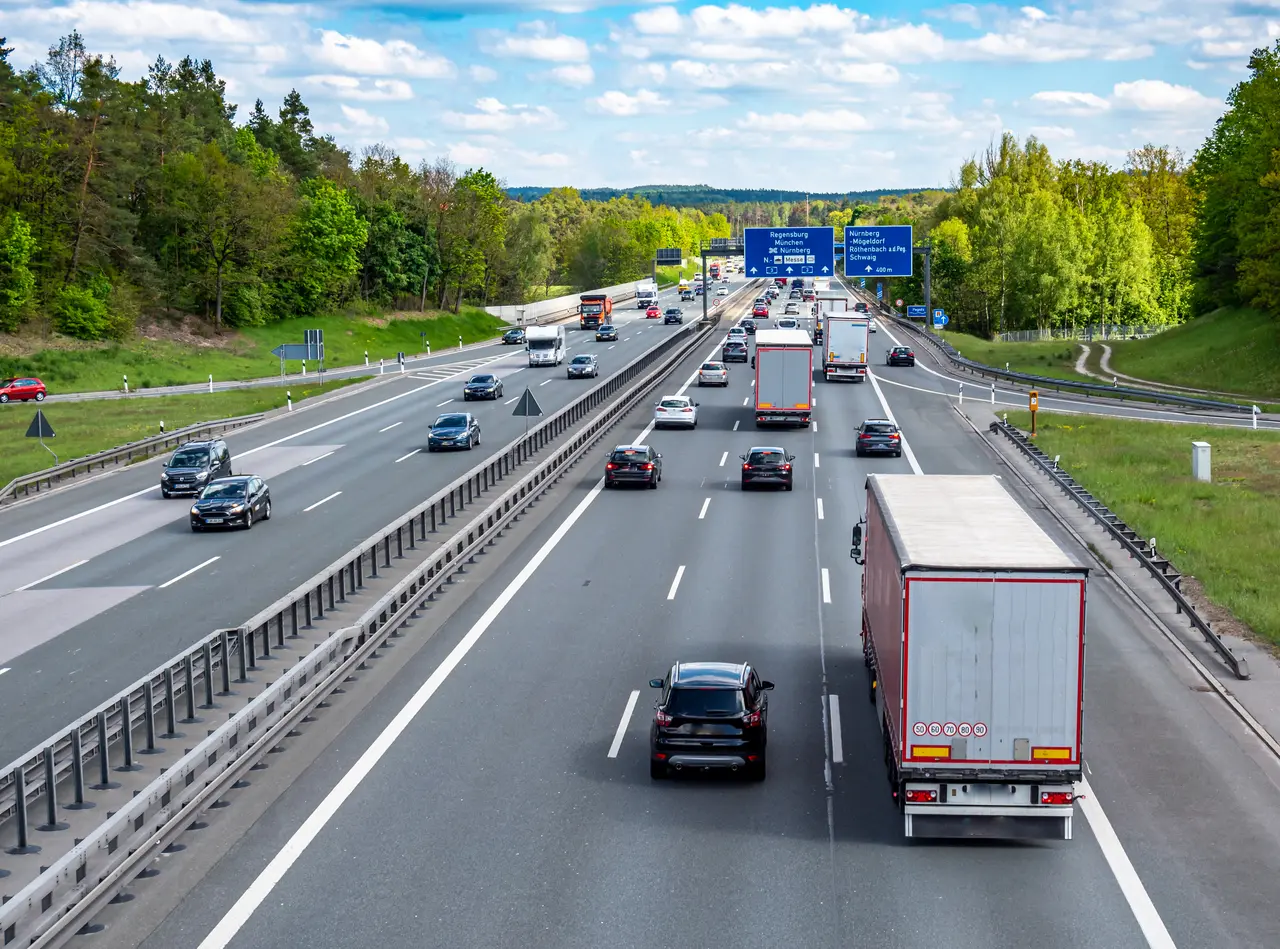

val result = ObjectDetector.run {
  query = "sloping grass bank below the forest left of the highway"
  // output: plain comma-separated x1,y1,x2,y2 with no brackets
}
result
0,307,507,392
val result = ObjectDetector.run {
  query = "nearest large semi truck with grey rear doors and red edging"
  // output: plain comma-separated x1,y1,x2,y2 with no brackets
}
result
850,474,1088,840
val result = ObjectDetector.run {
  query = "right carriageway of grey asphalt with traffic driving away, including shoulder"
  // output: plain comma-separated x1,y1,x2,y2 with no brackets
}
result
124,303,1280,949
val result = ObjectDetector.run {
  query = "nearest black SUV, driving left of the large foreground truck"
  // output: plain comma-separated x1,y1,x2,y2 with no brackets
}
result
649,662,773,781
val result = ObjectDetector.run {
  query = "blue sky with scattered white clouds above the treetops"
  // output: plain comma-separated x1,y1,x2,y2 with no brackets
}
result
0,0,1280,191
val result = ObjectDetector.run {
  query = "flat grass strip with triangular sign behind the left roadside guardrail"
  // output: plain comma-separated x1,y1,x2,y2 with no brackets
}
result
0,379,364,487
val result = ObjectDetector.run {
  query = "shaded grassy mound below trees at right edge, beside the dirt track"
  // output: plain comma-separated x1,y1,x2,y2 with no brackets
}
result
1107,309,1280,400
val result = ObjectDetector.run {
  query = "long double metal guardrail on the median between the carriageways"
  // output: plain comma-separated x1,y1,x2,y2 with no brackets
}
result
0,285,747,945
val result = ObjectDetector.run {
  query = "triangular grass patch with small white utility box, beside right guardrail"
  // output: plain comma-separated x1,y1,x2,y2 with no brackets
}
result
1009,412,1280,645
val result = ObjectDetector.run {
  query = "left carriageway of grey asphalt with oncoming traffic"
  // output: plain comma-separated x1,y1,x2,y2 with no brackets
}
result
0,280,741,762
